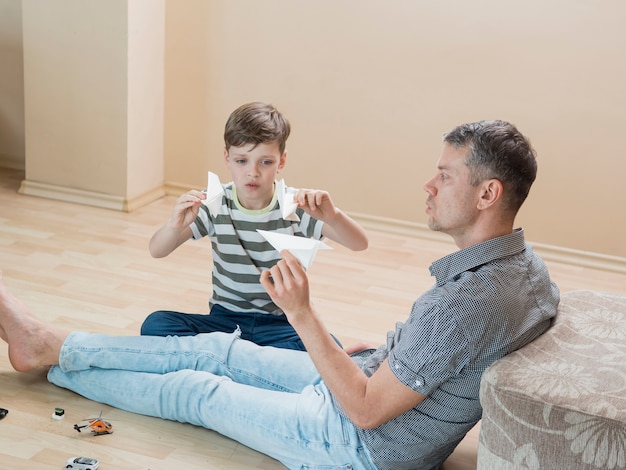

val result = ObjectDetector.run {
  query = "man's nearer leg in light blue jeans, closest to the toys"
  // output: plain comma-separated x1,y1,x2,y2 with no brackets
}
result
49,366,375,470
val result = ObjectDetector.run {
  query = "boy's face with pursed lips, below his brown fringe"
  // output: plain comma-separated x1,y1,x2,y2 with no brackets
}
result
224,142,287,210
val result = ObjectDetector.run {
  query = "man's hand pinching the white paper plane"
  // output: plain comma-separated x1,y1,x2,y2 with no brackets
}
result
261,250,311,321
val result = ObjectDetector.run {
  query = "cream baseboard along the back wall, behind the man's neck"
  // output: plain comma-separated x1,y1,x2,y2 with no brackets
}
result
350,213,626,274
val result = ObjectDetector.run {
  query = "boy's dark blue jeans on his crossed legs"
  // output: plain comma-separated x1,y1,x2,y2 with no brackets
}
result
141,304,305,351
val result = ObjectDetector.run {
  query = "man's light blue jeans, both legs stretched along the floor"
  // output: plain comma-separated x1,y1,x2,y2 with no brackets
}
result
48,331,376,470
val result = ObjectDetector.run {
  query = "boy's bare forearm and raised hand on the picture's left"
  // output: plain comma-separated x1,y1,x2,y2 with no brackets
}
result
148,191,206,258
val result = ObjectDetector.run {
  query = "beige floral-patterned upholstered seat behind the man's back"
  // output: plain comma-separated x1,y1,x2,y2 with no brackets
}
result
478,291,626,470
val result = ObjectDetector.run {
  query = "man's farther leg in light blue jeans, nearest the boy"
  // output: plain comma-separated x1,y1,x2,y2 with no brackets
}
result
53,331,320,392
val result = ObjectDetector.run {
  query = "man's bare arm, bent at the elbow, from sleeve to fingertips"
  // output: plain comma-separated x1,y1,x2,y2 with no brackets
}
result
261,251,425,429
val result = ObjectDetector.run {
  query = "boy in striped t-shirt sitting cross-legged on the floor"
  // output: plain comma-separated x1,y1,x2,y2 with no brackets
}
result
141,102,368,350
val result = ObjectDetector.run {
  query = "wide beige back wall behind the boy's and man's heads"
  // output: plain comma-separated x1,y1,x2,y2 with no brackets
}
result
0,0,626,258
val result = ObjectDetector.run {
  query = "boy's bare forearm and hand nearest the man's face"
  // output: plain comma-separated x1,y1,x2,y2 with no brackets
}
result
294,189,369,251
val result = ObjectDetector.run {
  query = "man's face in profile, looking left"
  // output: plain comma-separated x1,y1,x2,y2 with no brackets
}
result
424,144,480,245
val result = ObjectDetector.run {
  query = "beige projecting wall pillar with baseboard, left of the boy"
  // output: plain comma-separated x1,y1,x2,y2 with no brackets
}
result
20,0,165,210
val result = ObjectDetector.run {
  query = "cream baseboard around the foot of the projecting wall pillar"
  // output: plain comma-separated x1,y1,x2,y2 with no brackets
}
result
18,180,165,212
